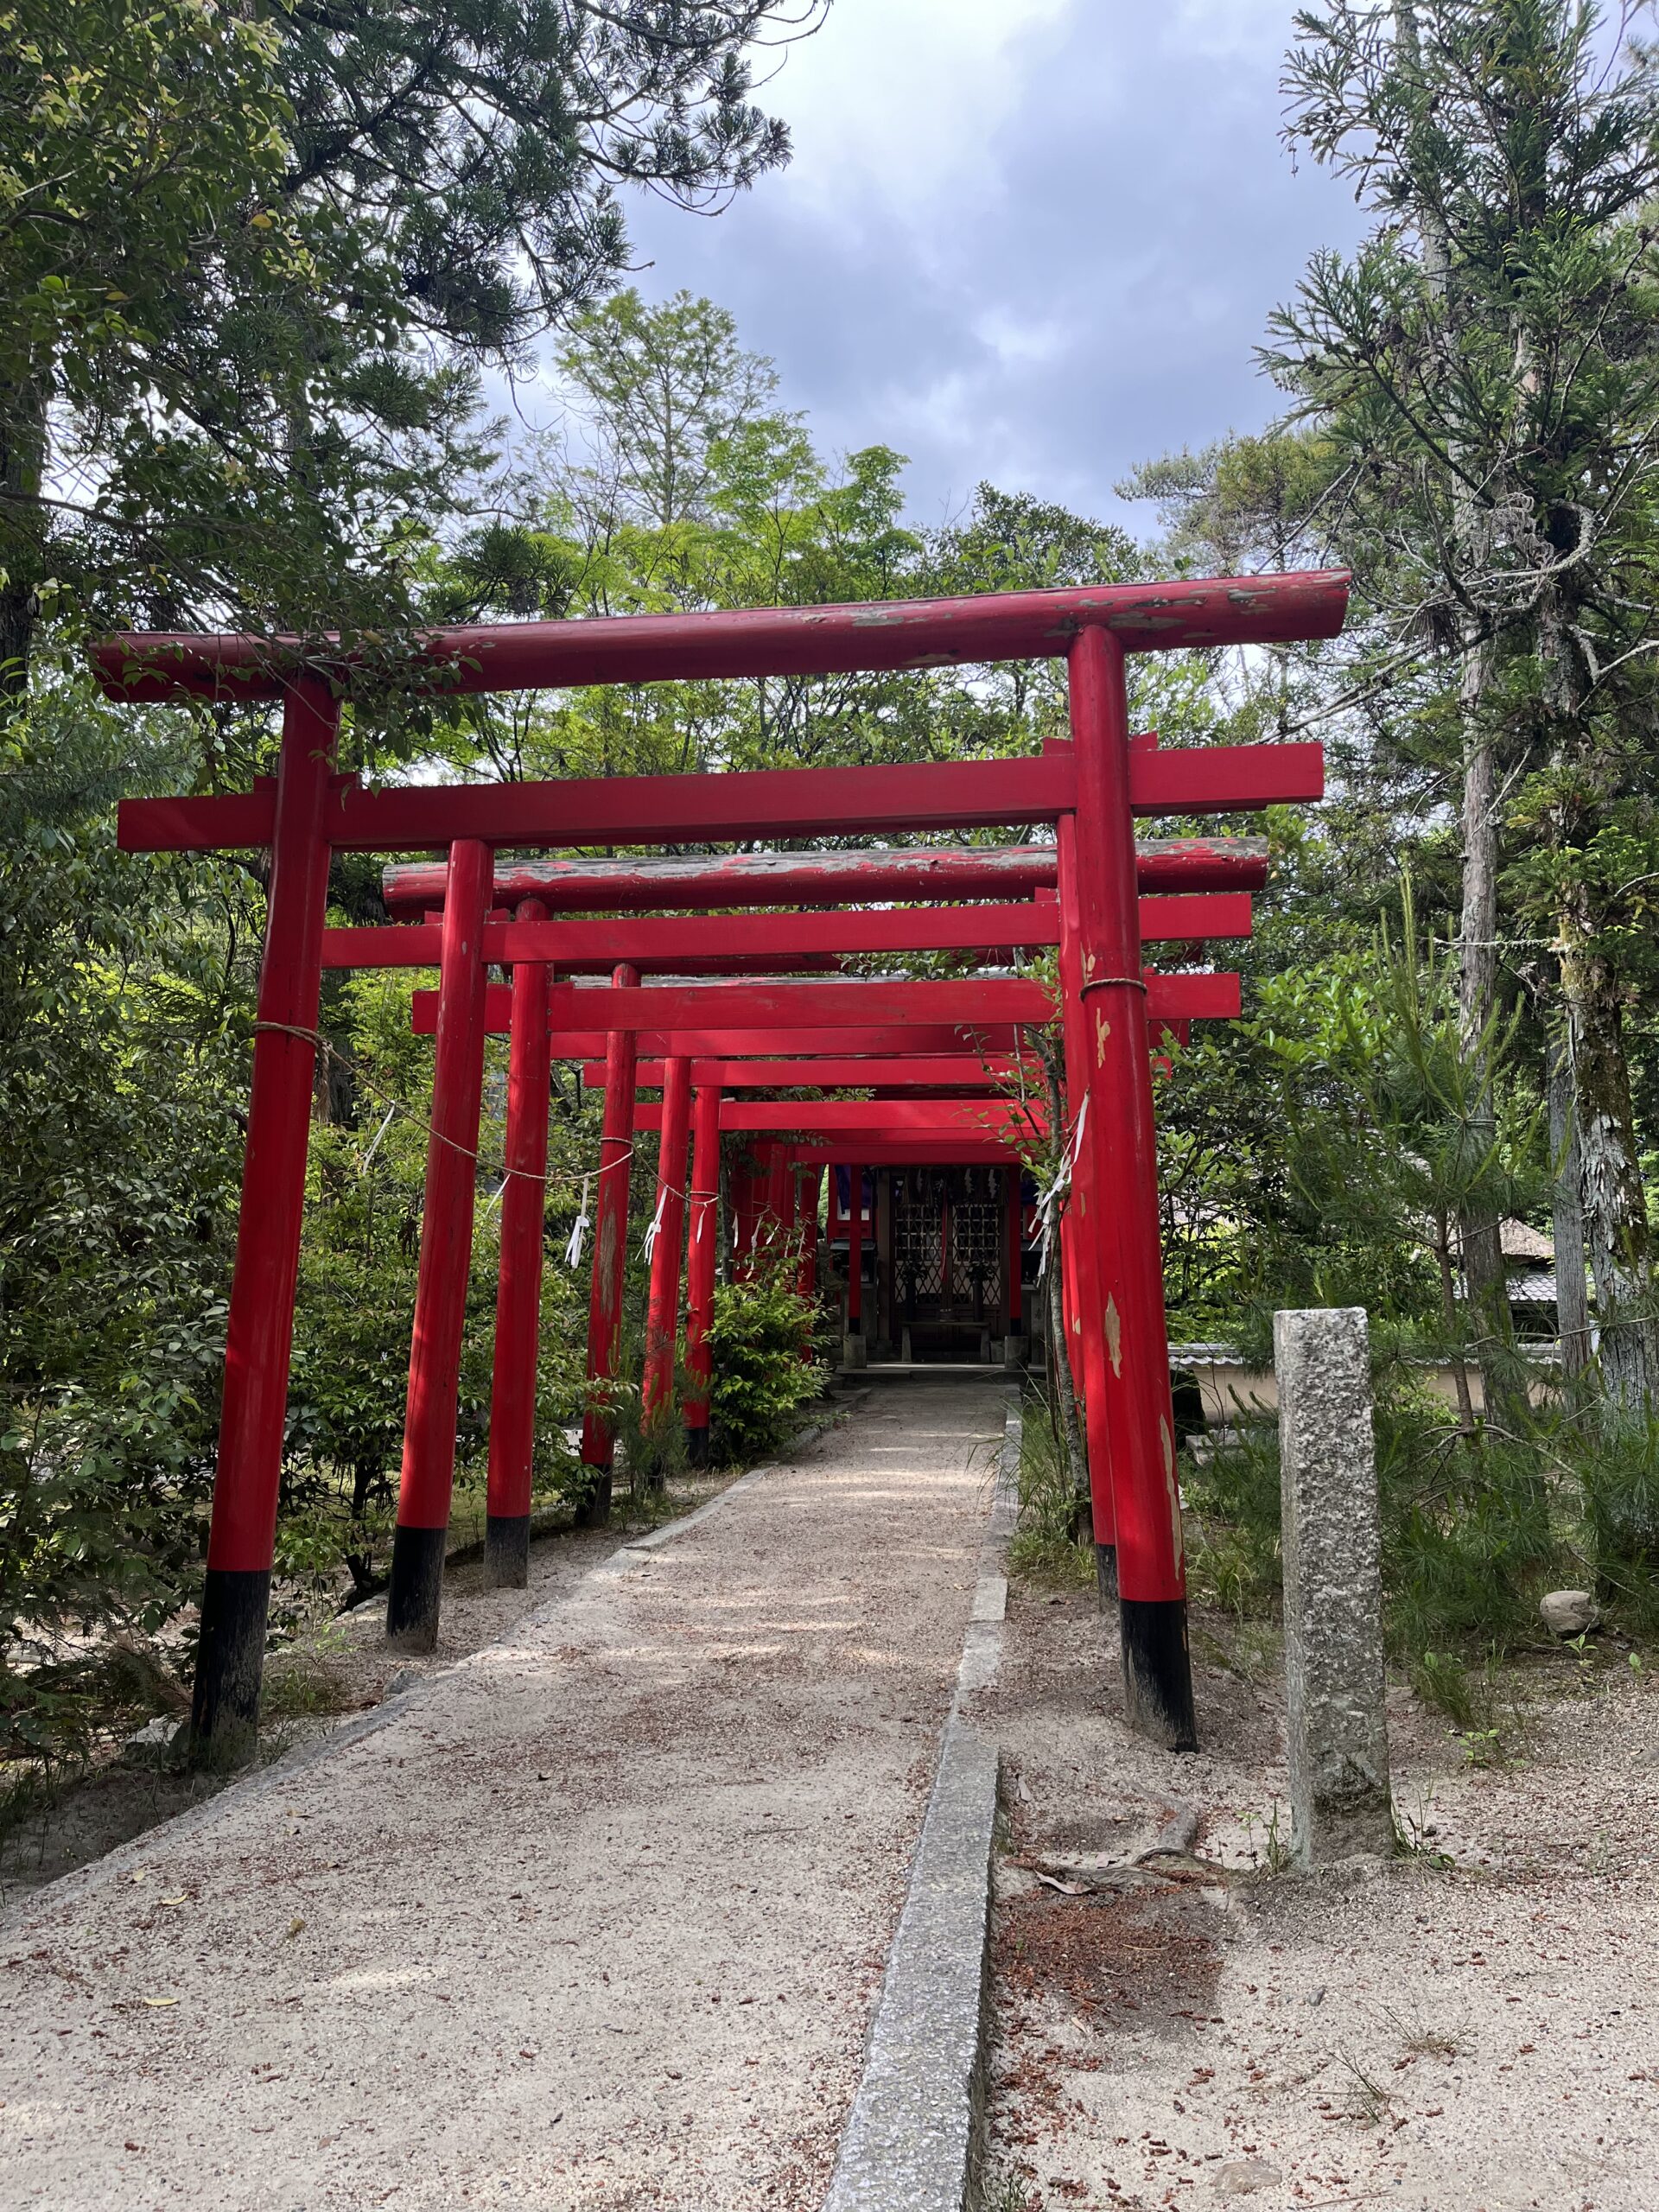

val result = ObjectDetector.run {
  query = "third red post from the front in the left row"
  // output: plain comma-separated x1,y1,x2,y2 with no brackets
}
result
485,898,550,1591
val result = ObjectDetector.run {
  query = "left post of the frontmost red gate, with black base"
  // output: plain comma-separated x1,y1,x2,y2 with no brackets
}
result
190,677,340,1765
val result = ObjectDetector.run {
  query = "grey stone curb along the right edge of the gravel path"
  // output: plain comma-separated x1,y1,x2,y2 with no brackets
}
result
823,1394,1022,2212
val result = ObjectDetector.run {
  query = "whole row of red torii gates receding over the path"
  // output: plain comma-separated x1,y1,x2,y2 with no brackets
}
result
95,570,1347,1761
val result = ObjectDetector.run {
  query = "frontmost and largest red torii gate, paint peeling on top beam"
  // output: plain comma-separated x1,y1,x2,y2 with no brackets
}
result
93,573,1347,1754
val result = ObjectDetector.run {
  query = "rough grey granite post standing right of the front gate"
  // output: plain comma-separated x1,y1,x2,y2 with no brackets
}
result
1274,1305,1394,1867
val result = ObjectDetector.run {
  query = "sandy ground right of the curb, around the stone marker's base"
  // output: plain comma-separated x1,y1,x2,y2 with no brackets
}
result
984,1586,1659,2212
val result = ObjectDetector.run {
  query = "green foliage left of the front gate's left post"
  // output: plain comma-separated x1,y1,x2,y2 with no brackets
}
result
0,690,257,1752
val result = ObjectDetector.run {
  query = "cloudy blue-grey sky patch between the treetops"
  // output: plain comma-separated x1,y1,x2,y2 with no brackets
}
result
522,0,1360,532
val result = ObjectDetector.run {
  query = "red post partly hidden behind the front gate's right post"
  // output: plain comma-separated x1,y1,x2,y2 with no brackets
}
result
1055,814,1123,1595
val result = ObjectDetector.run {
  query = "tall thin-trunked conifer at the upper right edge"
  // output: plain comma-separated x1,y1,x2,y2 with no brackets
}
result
1263,0,1659,1407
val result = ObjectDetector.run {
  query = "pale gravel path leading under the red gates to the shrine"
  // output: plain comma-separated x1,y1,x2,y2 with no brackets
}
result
0,1376,1004,2212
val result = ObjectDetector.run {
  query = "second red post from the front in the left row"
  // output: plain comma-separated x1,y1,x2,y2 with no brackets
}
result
385,838,493,1650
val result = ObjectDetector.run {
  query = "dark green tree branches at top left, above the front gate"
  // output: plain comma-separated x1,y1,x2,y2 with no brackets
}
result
0,0,821,688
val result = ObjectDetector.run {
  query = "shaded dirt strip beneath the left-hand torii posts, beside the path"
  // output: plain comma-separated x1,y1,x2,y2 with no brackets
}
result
0,1473,747,1911
